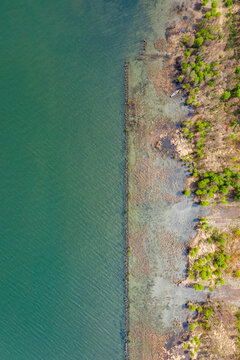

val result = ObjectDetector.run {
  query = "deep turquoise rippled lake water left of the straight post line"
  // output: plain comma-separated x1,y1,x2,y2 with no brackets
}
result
0,0,173,360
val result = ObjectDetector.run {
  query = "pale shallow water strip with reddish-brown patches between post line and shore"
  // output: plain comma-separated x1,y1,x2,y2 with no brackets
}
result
127,16,207,354
